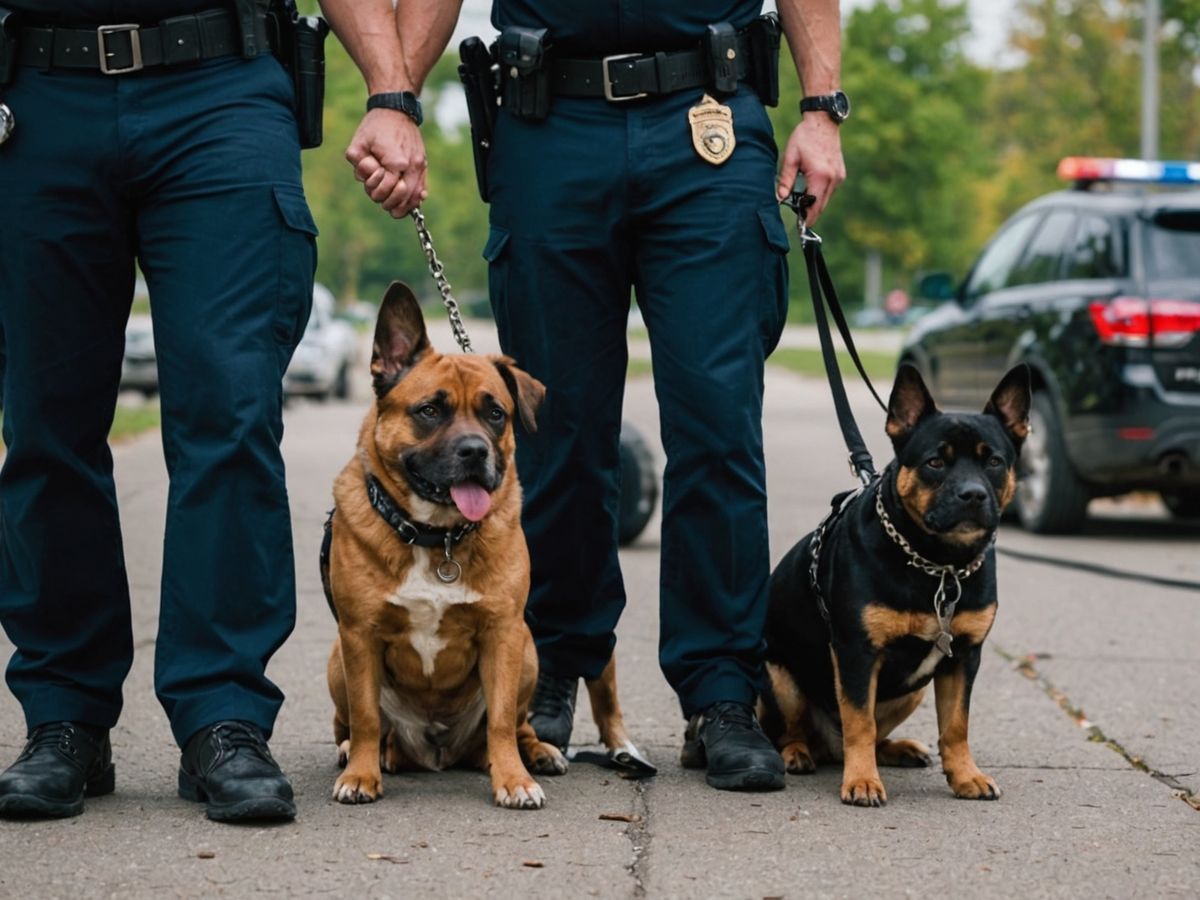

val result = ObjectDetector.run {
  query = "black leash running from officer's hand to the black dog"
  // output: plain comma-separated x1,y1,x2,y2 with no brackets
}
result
781,186,888,485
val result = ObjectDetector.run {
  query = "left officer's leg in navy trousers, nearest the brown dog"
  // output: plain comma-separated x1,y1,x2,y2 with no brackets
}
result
131,58,316,817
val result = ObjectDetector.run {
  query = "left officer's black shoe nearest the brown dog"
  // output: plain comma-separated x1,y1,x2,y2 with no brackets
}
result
179,721,296,822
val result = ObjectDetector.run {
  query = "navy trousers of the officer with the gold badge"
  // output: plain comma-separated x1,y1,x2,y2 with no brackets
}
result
485,88,787,715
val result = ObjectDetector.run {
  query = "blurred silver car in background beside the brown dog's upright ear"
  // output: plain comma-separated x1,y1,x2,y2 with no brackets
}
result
283,284,359,400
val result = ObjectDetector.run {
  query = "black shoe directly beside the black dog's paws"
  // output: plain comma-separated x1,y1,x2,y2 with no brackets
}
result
679,701,784,791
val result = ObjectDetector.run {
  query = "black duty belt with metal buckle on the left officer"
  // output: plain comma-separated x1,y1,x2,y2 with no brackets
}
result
18,10,269,74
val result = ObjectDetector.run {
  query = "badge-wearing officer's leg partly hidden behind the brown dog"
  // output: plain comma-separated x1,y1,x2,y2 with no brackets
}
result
485,100,630,746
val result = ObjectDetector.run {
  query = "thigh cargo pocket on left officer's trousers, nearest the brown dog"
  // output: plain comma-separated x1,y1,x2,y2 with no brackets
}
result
271,185,317,352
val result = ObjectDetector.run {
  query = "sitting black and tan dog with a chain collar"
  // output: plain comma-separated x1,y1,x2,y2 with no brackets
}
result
760,366,1031,806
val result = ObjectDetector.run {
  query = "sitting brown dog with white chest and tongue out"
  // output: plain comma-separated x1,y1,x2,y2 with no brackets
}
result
322,283,628,809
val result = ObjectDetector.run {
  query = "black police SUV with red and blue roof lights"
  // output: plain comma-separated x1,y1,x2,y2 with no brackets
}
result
900,157,1200,533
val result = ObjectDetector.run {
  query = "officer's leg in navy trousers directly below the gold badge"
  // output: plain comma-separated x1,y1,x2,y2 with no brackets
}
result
636,90,787,787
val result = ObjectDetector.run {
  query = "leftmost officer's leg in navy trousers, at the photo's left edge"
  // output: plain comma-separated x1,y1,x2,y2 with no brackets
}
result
0,70,133,815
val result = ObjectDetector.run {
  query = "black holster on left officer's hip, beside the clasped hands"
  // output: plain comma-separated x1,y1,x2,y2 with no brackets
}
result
268,0,329,150
